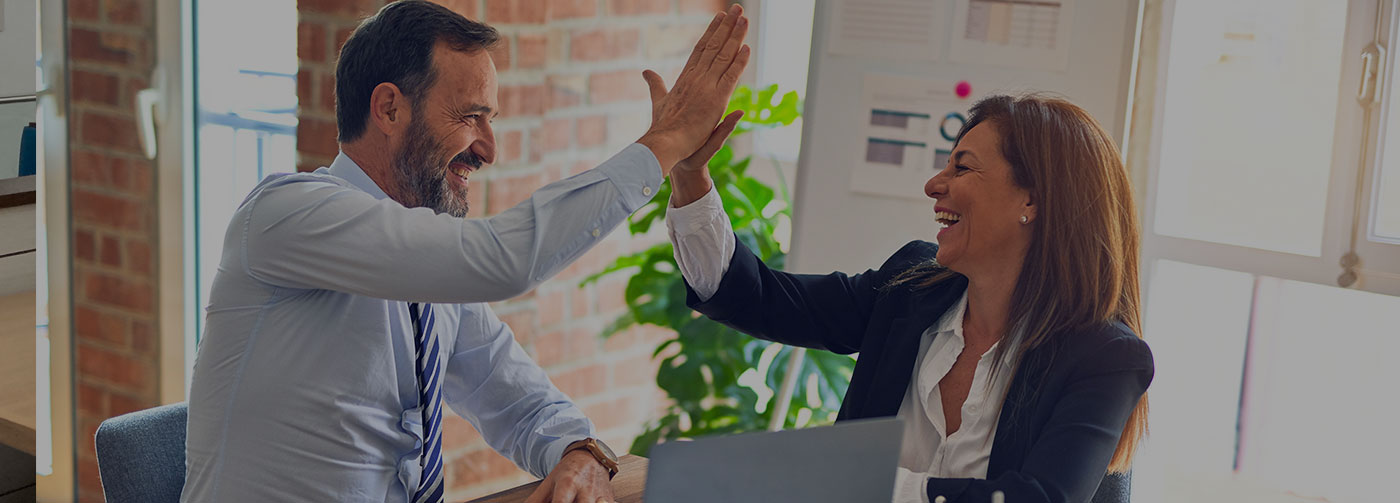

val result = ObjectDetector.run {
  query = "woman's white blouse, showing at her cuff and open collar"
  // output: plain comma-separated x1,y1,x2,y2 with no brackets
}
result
666,189,1014,503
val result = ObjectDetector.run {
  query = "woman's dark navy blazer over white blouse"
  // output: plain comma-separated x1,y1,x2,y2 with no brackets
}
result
686,240,1152,503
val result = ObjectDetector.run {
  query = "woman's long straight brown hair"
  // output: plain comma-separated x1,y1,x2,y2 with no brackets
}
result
890,95,1147,472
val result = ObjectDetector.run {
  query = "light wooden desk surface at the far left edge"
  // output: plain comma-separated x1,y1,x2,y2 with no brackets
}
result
0,291,35,454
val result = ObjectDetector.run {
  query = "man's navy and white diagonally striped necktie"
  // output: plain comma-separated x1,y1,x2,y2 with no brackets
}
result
409,303,442,503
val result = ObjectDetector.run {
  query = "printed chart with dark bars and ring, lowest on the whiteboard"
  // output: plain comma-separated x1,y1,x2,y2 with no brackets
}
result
851,73,977,199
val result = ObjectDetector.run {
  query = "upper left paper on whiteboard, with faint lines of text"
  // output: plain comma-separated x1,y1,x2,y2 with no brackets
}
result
827,0,945,62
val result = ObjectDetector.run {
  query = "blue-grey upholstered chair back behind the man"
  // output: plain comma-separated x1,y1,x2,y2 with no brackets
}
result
97,402,189,503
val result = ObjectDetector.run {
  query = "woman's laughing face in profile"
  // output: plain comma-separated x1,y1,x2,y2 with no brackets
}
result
924,120,1036,276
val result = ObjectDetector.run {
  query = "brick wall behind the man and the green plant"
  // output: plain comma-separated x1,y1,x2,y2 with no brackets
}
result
297,0,725,500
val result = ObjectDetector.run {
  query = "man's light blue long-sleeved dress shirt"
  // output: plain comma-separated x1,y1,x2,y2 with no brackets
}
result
181,144,662,503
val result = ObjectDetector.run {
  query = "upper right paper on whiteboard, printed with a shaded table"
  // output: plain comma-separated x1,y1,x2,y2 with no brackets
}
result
948,0,1074,71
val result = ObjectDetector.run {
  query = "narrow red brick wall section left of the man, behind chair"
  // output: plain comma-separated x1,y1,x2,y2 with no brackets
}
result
69,0,157,502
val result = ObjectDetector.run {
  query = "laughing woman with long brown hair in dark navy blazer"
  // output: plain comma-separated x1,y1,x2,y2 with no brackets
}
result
666,95,1152,503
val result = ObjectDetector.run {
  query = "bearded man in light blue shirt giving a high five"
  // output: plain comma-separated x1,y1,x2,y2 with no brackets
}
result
182,1,749,503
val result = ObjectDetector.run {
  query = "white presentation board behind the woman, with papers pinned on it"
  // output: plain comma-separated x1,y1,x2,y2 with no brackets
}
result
787,0,1140,273
